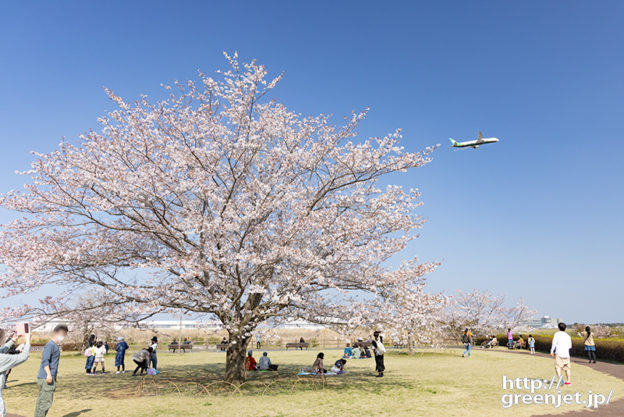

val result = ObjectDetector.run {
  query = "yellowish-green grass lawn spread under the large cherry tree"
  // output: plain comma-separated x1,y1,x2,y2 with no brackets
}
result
4,349,624,417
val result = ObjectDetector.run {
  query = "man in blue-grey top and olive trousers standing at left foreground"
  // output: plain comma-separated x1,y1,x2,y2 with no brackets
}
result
35,324,69,417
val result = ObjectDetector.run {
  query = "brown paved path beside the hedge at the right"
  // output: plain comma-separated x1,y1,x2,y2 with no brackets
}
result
500,350,624,417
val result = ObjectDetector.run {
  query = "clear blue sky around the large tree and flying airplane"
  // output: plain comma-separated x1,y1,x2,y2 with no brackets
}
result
0,1,624,322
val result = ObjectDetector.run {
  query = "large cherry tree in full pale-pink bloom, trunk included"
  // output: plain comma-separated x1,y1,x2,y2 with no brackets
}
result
0,55,433,381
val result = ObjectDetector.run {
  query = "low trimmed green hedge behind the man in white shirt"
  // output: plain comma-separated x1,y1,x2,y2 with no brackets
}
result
474,333,624,362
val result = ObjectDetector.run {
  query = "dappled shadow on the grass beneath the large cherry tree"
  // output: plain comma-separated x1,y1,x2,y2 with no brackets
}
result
14,352,424,400
